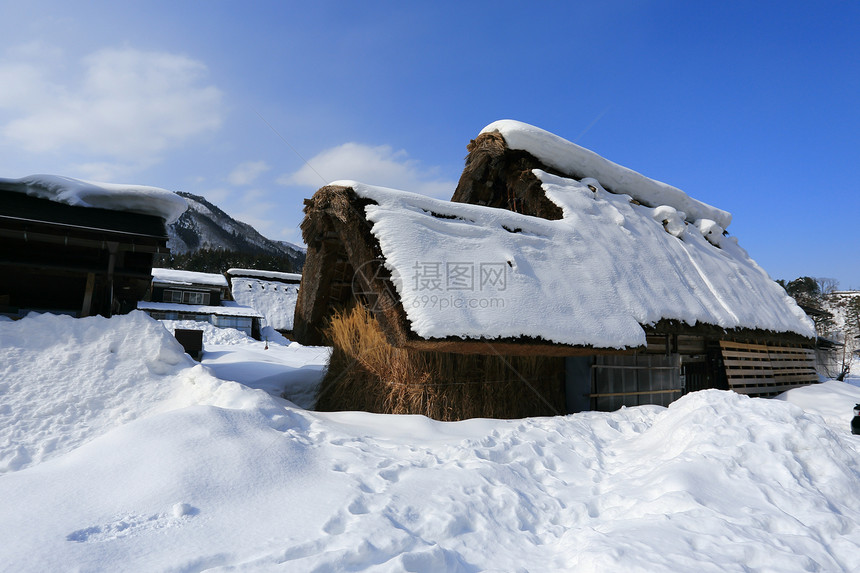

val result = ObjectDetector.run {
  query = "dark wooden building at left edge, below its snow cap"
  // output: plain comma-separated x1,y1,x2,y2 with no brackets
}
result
0,174,183,317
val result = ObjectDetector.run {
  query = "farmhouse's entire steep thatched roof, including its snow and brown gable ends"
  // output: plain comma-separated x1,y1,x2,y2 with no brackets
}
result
295,122,814,355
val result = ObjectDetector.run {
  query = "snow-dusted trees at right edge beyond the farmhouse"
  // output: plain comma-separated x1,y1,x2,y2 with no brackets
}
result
776,277,860,380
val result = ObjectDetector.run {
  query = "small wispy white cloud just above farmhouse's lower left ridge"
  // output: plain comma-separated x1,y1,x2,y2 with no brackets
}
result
278,143,457,199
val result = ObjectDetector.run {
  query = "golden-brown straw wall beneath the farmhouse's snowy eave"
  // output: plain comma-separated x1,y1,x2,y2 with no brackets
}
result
317,305,565,421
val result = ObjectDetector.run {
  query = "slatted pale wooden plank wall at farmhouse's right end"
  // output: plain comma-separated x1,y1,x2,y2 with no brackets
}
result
720,340,818,397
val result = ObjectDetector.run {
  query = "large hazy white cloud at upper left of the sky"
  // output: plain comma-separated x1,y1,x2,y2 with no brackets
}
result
0,48,223,165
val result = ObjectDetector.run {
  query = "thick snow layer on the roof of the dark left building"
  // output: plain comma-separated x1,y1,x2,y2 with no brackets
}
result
0,175,188,224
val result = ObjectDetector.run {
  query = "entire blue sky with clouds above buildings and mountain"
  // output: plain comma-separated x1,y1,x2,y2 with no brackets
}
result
0,0,860,288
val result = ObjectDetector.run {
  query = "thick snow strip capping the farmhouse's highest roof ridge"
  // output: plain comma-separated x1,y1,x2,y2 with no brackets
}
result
481,119,732,229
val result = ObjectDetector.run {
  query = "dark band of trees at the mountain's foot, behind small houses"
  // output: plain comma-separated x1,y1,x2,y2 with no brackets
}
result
155,249,301,273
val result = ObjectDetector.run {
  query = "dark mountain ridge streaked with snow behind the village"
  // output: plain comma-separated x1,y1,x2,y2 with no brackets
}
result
167,191,305,270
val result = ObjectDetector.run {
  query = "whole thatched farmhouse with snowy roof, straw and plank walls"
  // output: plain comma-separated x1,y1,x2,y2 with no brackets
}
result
295,121,816,419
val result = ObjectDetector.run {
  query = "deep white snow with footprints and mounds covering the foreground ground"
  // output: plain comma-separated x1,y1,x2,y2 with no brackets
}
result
0,312,860,572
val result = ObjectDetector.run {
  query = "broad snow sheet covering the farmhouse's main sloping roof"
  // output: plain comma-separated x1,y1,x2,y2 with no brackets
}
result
314,177,815,349
